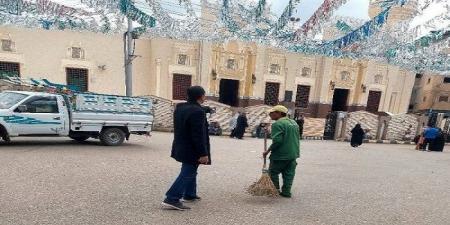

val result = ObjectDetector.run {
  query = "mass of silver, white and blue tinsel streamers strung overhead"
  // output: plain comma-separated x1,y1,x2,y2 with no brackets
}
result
0,0,450,73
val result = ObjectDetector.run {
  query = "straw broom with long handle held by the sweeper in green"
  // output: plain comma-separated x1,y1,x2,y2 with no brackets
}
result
247,130,279,197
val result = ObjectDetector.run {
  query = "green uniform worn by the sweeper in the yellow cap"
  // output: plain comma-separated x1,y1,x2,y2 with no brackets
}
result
269,117,300,197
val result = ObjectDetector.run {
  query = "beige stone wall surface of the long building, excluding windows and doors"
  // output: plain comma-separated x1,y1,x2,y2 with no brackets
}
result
0,27,414,117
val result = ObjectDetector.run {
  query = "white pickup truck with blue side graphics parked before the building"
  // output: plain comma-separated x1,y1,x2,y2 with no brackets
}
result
0,91,153,146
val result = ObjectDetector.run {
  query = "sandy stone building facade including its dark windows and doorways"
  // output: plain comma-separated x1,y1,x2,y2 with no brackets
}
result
0,1,428,118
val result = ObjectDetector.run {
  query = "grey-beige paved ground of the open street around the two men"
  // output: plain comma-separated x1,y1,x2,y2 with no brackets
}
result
0,133,450,225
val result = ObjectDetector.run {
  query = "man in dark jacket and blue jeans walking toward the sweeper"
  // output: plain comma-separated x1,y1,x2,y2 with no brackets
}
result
162,86,210,210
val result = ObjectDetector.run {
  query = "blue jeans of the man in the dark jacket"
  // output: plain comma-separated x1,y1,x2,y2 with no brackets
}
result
166,163,198,203
